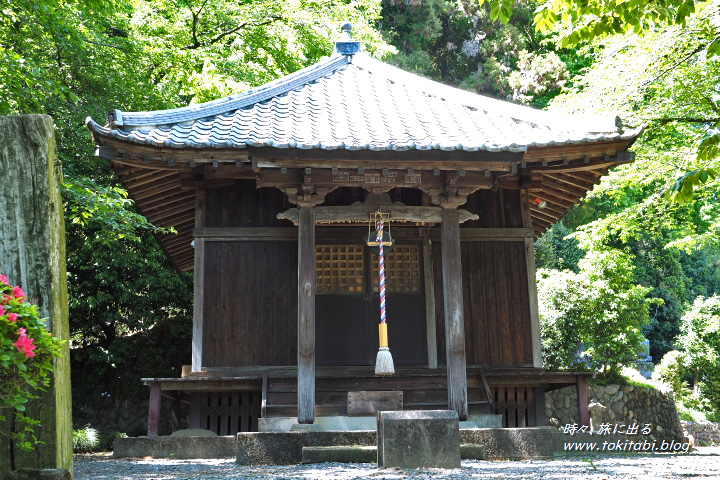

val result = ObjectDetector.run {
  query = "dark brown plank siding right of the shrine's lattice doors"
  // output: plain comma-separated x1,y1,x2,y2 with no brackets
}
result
433,189,532,366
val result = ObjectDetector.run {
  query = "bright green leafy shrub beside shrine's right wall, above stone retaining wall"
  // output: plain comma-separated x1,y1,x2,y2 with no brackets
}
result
538,251,650,376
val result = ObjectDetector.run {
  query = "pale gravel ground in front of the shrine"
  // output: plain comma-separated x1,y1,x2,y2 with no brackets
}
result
75,447,720,480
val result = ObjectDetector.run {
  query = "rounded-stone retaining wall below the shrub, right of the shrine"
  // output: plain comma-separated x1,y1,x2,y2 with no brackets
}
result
545,385,685,442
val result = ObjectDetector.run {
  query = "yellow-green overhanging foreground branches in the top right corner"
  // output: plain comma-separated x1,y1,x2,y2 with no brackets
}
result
478,0,720,197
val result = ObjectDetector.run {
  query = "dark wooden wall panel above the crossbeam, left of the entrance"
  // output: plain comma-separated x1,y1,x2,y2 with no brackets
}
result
205,180,294,228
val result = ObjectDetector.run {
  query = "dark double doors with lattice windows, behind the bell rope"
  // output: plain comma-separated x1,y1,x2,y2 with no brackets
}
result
315,243,427,365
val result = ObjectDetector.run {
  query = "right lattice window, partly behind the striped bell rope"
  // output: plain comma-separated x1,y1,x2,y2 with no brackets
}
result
371,245,421,293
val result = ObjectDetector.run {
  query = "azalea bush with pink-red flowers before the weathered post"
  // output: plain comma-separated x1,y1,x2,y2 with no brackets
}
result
0,275,62,450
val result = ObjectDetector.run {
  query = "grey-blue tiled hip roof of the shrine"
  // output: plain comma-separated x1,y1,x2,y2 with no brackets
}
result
88,53,638,152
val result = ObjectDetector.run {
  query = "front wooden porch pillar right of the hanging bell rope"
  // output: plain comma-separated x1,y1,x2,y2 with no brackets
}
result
440,207,468,420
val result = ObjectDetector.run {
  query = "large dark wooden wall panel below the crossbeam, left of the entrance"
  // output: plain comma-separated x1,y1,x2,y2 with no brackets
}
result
203,241,297,367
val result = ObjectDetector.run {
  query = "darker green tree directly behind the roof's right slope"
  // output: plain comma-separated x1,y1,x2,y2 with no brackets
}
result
378,0,584,106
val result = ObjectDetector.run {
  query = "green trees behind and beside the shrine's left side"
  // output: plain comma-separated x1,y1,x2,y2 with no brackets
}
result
0,0,390,412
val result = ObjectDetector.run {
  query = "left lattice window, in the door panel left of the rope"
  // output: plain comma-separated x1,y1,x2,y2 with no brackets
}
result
315,245,365,293
